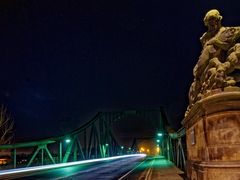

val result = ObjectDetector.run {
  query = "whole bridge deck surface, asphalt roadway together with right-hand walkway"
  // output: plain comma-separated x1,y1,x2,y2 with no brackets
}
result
0,156,183,180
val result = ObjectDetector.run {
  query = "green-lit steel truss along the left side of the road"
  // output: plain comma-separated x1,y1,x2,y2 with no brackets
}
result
0,108,167,168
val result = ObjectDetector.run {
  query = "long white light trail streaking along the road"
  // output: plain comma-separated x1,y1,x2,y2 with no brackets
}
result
0,154,146,178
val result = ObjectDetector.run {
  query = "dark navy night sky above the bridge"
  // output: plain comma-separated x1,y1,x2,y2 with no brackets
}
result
0,0,240,141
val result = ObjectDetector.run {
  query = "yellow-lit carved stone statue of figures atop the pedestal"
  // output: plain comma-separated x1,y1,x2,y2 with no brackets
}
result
185,9,240,116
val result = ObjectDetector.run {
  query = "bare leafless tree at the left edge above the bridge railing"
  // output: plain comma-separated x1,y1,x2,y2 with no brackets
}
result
0,105,14,145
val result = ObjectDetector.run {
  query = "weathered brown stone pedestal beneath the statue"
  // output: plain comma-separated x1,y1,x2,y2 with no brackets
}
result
183,91,240,180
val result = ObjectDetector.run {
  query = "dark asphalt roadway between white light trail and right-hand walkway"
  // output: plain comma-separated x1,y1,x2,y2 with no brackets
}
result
0,156,144,180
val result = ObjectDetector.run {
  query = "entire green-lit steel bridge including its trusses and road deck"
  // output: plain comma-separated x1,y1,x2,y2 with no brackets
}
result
0,108,186,179
